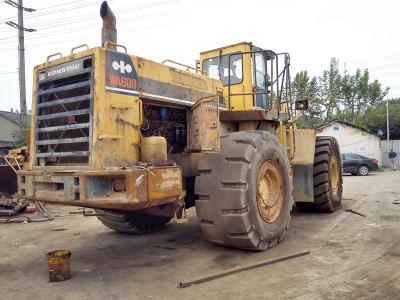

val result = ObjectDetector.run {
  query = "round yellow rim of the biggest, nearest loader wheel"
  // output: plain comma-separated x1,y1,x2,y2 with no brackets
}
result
257,160,283,223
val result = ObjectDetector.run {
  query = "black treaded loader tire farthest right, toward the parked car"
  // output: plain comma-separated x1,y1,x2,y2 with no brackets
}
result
296,136,343,212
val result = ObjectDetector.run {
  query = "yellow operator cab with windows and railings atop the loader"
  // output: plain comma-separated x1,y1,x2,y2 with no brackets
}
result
200,42,290,110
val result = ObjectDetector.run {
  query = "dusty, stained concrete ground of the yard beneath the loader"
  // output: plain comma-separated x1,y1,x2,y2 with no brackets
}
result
0,171,400,300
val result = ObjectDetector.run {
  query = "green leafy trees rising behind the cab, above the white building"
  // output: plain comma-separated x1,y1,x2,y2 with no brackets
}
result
292,66,389,128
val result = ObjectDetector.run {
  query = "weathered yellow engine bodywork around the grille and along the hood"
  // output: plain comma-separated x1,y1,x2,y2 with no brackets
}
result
28,47,222,170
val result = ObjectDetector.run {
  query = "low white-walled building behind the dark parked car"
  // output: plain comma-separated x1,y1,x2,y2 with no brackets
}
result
317,121,382,165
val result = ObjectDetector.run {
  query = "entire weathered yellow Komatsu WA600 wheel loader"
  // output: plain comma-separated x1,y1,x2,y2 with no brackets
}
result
17,2,342,250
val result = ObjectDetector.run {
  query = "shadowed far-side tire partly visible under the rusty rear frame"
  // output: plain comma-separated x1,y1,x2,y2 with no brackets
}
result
96,210,171,234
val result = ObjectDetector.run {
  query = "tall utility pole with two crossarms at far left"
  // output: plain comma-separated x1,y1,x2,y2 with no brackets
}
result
4,0,36,128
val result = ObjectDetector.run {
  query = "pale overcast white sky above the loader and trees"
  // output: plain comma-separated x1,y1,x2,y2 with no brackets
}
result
0,0,400,111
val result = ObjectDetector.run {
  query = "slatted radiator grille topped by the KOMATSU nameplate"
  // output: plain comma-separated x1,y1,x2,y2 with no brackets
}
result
34,57,93,166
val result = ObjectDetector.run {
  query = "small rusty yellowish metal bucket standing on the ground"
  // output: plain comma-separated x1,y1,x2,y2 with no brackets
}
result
47,250,71,282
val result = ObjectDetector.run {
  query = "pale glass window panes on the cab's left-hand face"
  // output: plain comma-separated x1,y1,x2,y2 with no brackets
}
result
203,53,243,85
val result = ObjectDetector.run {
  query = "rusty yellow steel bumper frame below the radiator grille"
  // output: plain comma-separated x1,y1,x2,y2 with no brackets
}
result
17,166,183,210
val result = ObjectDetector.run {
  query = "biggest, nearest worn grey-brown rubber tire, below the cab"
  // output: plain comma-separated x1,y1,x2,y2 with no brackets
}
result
195,131,293,250
